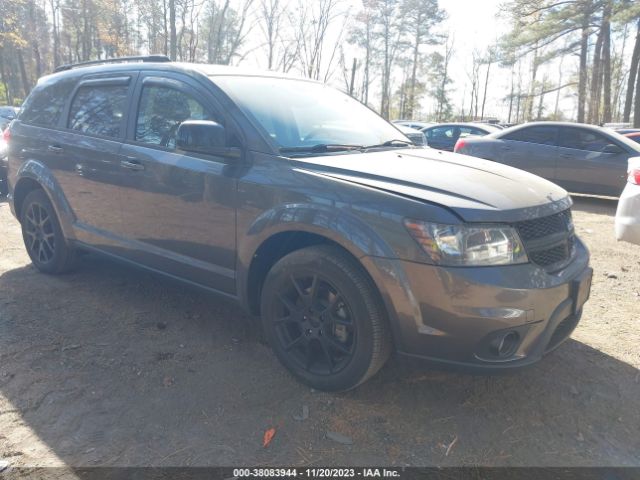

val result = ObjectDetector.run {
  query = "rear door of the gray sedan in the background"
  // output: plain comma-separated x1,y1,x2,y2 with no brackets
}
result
495,125,558,181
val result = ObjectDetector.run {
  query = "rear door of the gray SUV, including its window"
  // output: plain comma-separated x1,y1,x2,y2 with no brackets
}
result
55,73,134,239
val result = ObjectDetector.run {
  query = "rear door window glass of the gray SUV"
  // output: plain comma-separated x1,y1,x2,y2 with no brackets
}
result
69,85,129,137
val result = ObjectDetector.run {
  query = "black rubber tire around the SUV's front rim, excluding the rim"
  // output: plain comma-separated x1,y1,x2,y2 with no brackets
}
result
261,248,376,391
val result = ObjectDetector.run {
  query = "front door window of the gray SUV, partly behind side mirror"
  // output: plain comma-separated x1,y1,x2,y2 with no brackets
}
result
136,86,217,148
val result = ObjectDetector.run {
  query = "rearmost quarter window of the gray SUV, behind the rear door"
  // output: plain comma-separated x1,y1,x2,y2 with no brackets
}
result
20,79,76,127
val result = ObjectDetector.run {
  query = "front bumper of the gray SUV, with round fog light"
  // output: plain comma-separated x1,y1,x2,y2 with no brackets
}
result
362,240,592,371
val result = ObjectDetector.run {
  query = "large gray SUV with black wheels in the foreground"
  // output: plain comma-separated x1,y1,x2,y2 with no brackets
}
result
8,56,591,391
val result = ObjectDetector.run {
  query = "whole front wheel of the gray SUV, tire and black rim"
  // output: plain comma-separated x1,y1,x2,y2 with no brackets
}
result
261,245,391,391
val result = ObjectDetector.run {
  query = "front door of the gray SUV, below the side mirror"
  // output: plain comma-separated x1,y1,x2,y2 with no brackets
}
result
122,73,240,294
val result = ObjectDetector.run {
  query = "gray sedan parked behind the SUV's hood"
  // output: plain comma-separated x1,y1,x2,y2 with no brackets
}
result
454,122,640,197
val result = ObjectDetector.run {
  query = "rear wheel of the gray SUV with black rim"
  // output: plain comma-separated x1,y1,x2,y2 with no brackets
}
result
20,190,75,274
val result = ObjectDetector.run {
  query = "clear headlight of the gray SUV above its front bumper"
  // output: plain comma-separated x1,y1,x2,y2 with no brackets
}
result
404,220,529,266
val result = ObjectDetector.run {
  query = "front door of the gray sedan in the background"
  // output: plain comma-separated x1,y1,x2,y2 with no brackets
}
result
556,127,629,197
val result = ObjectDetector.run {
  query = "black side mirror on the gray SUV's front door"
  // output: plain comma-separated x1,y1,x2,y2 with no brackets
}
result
176,120,240,158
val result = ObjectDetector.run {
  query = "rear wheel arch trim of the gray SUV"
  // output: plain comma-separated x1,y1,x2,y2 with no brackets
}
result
11,160,75,239
